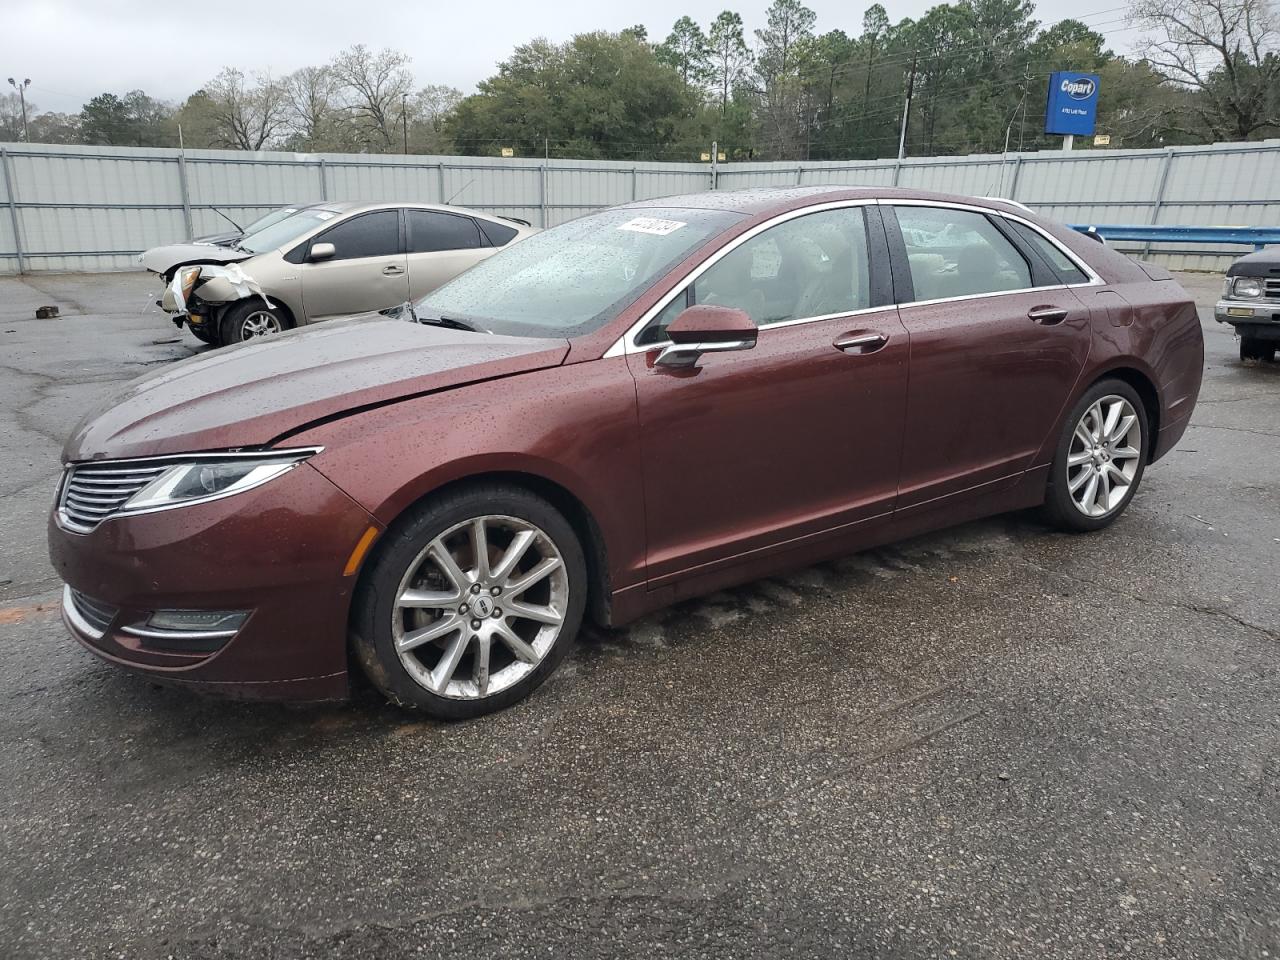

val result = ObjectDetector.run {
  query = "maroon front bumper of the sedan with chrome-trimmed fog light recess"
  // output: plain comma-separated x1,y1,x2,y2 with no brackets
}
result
49,463,376,700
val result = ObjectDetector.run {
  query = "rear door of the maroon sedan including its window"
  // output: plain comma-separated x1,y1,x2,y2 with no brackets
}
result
882,202,1091,509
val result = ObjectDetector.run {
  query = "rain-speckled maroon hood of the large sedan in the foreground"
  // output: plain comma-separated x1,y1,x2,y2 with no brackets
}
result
63,315,568,461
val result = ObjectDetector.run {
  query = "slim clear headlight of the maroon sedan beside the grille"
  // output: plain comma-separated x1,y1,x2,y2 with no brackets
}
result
120,447,320,513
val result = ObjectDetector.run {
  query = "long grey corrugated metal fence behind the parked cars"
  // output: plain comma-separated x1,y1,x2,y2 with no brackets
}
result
0,141,1280,274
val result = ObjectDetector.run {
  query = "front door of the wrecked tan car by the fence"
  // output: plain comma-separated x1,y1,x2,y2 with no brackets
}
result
298,209,408,321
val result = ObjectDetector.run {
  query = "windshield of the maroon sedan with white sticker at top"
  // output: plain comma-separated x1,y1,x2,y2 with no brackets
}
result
413,207,742,337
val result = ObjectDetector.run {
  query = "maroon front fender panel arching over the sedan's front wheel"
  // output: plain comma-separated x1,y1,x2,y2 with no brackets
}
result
288,357,645,589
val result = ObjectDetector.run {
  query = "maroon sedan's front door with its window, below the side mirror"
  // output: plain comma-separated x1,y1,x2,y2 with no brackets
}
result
628,206,909,586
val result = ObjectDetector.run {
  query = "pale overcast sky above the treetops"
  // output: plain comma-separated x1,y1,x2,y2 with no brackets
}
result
0,0,1134,111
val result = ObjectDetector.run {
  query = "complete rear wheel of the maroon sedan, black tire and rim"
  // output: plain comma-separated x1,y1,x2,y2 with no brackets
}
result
1044,379,1151,532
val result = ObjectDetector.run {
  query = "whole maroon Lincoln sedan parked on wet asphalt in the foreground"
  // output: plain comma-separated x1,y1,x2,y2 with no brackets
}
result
49,187,1203,718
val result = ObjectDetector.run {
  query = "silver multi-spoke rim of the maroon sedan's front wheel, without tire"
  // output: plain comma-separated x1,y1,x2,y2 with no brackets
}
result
392,516,568,700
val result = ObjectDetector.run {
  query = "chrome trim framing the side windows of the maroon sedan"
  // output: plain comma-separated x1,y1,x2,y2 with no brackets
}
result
602,197,1106,360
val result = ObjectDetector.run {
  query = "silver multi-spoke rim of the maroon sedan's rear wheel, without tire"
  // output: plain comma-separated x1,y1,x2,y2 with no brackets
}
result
1066,394,1142,520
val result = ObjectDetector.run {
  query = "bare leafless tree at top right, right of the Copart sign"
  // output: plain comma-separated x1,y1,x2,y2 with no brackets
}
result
1132,0,1280,140
